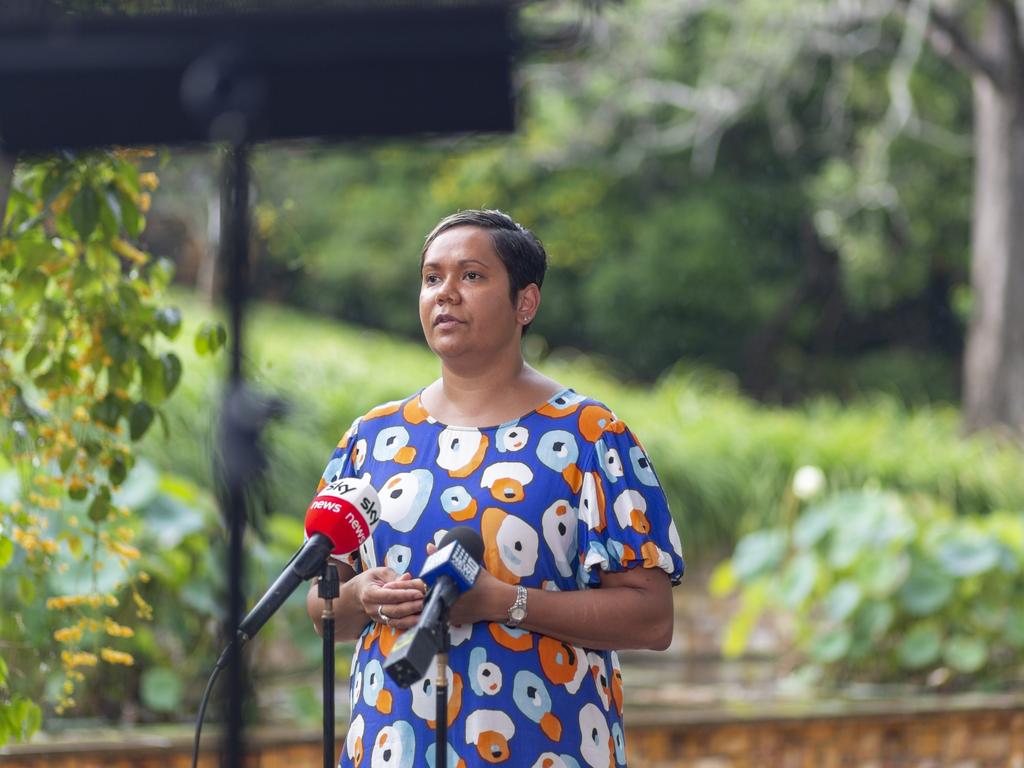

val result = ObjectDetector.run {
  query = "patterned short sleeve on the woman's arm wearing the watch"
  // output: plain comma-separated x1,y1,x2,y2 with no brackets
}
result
577,415,684,587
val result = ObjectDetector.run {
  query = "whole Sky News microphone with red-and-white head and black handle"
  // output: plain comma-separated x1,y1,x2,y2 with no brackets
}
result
239,477,380,643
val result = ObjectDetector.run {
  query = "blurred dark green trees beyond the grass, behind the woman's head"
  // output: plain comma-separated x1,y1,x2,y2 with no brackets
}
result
136,0,972,402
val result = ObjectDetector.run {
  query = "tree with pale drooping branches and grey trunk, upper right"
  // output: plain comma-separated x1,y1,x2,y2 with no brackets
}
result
545,0,1024,431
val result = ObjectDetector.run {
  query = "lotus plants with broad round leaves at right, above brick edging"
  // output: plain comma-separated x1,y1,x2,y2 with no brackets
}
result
712,490,1024,686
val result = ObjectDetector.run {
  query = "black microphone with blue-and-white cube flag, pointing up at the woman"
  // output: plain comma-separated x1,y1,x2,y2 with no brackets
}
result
384,525,483,688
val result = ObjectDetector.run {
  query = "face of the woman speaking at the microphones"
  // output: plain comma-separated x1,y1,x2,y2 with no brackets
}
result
420,226,521,359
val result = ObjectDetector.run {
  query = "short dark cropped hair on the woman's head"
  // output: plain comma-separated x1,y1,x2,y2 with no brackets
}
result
420,209,548,333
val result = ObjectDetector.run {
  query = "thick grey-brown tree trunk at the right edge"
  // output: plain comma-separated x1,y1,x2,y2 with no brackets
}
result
964,2,1024,434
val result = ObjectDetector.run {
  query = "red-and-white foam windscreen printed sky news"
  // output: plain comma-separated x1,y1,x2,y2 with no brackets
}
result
306,477,380,555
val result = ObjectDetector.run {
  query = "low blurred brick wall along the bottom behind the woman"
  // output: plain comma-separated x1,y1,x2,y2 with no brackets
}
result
0,694,1024,768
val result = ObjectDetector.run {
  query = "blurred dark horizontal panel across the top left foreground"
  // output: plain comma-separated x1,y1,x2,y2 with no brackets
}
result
0,0,514,153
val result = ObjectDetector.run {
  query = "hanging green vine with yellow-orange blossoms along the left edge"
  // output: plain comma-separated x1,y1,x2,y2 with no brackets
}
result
0,150,223,743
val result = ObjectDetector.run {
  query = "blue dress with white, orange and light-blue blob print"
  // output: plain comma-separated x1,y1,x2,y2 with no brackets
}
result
321,389,683,768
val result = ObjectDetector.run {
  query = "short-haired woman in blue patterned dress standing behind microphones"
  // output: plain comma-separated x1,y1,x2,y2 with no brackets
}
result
307,211,683,768
